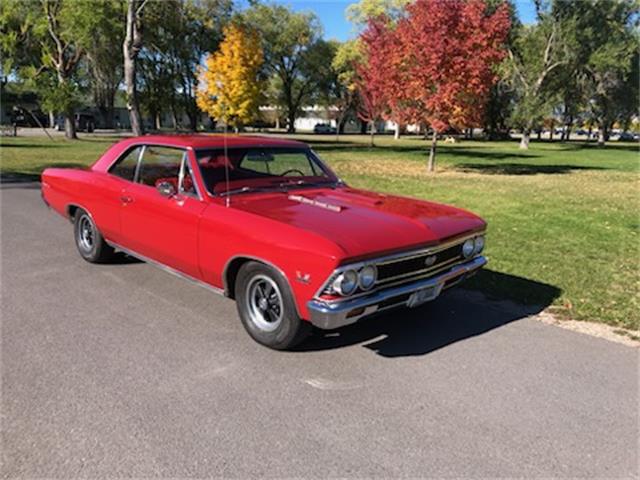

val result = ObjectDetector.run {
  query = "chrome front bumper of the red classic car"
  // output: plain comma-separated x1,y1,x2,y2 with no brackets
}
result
307,257,487,330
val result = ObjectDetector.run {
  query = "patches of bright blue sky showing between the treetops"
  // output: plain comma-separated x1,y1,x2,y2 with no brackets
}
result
277,0,536,41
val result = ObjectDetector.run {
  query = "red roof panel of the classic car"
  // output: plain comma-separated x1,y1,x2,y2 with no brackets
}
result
123,134,307,149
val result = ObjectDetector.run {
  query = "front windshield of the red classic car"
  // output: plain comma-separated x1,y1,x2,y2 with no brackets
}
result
196,147,338,195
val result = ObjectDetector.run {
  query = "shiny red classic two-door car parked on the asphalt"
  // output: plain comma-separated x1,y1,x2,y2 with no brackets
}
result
42,135,486,349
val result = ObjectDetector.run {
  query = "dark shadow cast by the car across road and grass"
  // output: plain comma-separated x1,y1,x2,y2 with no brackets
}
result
296,270,561,358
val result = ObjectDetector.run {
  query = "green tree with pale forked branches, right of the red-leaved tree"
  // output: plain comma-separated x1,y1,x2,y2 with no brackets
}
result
506,16,568,149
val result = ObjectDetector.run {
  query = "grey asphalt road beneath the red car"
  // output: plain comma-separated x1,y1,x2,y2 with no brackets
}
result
1,179,639,478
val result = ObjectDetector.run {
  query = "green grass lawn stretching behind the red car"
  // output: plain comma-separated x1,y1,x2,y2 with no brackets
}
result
1,135,640,330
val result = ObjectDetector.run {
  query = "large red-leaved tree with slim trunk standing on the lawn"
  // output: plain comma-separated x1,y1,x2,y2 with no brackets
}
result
400,0,510,171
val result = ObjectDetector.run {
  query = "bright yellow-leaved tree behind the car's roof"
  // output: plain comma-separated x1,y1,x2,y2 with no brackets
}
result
196,23,264,128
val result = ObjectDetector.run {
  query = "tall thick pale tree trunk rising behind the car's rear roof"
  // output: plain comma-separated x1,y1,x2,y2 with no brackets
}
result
122,0,144,135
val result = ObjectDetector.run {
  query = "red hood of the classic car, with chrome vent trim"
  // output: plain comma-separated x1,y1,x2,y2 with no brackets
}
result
231,187,485,258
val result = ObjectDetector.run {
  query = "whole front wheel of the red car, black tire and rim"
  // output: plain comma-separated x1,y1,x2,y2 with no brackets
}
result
235,262,311,350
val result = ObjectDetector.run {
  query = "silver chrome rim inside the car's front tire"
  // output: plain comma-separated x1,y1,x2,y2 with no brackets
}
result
245,275,284,332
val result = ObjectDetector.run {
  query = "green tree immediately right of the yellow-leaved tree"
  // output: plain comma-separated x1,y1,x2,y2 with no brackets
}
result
244,4,327,132
